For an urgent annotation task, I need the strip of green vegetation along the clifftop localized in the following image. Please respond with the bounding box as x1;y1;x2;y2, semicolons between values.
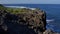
0;4;39;14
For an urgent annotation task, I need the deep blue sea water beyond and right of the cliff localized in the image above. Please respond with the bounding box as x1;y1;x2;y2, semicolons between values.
3;4;60;32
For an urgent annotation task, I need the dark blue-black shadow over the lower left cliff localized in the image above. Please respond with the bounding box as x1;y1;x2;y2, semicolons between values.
0;10;36;34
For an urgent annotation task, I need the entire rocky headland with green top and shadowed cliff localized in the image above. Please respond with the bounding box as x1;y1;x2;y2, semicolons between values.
0;5;59;34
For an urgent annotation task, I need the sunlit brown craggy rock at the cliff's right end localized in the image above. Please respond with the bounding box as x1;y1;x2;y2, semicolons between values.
18;11;46;32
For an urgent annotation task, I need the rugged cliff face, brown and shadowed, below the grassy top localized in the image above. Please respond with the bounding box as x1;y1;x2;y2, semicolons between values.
0;10;46;34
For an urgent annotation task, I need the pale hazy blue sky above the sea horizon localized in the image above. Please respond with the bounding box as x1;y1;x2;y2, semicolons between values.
0;0;60;4
